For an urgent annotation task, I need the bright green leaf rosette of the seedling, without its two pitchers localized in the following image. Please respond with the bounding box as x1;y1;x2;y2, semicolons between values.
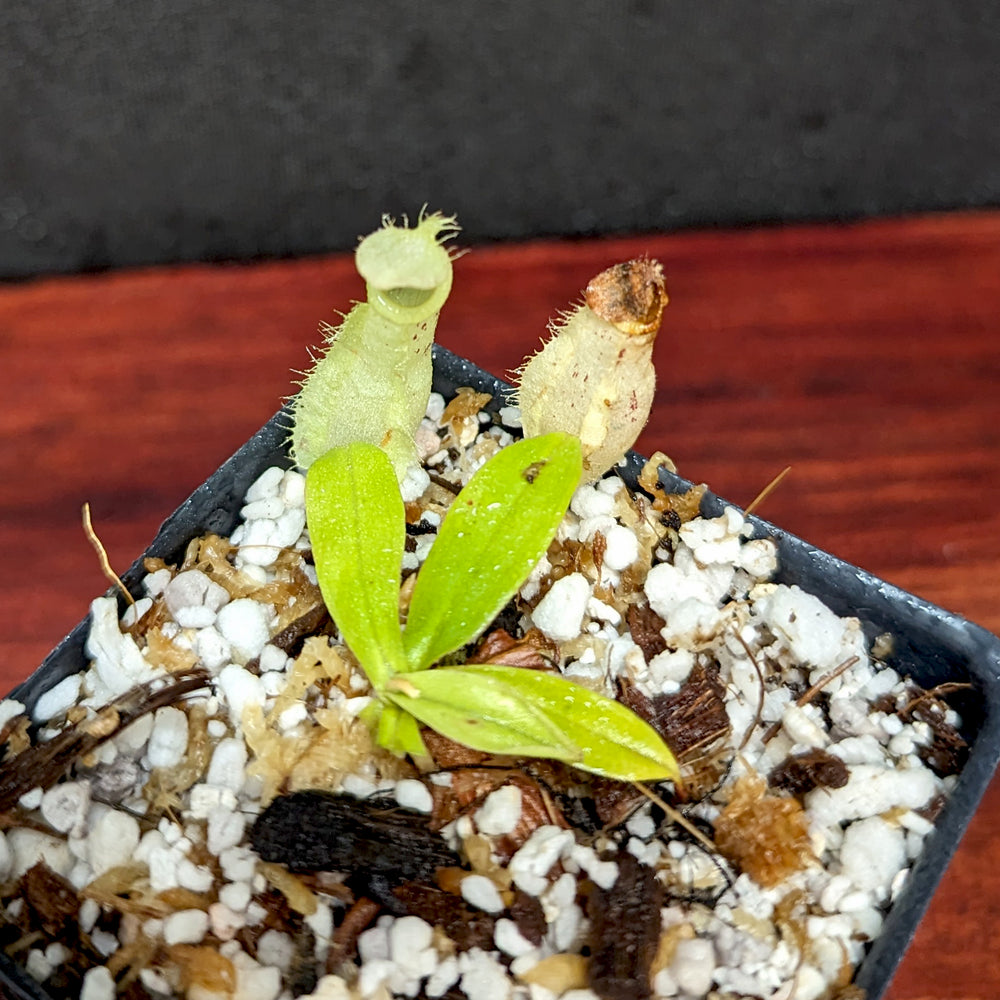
306;433;679;781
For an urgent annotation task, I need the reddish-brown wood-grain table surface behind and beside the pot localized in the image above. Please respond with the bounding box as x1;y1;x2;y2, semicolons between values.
0;213;1000;1000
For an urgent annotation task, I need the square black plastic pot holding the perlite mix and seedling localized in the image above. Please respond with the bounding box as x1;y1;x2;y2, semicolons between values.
0;347;1000;1000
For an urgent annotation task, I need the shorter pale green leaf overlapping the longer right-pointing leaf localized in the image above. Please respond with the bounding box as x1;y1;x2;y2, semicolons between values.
385;667;581;763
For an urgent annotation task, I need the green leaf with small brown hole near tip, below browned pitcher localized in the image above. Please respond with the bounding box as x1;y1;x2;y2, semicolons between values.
403;433;582;670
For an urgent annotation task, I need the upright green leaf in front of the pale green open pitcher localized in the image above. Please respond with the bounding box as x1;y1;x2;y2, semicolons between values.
306;442;406;691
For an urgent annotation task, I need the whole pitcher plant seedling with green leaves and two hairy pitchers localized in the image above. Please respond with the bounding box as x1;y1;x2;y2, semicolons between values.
291;214;679;781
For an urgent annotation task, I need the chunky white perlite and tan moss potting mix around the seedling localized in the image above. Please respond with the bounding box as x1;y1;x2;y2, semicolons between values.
0;394;959;1000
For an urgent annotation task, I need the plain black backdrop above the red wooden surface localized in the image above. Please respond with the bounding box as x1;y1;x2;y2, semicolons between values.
0;0;1000;277
